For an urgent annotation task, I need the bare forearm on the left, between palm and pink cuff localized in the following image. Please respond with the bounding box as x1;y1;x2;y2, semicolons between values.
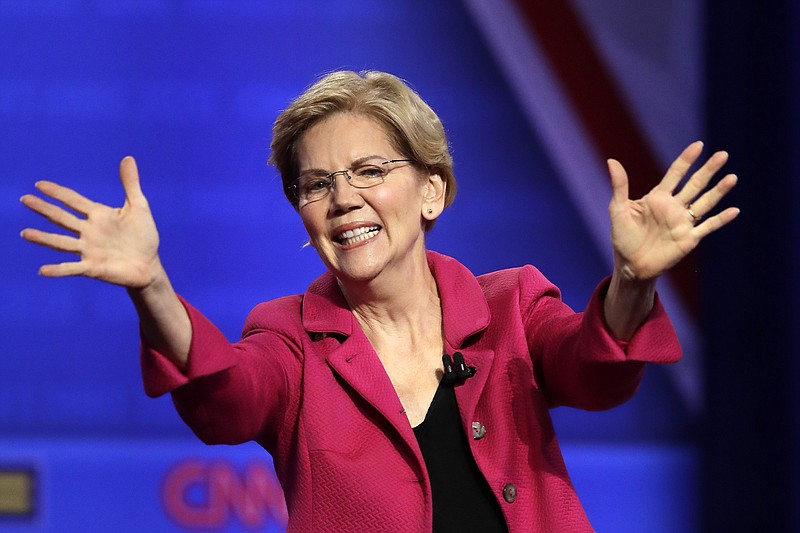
128;262;192;371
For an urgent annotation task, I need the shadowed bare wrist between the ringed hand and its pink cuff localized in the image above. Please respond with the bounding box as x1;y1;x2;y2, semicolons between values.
603;271;656;341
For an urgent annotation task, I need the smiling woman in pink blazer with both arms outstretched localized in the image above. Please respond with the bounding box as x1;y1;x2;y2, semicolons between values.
22;72;738;532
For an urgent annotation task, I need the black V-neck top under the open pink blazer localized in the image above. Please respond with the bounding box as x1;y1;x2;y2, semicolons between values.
414;382;508;533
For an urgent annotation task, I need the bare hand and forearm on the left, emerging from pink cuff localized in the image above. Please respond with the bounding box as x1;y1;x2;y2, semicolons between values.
21;157;192;370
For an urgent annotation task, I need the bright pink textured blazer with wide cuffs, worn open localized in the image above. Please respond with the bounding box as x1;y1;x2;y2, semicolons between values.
142;252;680;533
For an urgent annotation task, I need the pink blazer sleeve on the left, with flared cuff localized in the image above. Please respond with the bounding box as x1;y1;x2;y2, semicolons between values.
140;298;302;444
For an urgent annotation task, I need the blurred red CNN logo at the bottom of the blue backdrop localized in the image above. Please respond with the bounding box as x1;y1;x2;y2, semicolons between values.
161;459;287;529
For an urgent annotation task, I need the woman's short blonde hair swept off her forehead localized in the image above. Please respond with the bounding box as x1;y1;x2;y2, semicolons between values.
269;70;456;231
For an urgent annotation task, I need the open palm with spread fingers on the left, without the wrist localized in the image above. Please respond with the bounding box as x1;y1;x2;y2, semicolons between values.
20;156;165;290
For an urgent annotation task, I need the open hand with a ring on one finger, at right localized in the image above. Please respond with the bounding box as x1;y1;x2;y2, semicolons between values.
608;141;739;281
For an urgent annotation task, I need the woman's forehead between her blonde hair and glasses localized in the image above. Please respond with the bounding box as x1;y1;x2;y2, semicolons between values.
297;113;398;171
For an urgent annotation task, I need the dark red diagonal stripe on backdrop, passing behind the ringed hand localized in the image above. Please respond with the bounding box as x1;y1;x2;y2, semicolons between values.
514;0;697;313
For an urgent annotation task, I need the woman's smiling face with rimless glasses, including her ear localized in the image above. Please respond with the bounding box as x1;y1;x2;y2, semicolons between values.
297;113;444;282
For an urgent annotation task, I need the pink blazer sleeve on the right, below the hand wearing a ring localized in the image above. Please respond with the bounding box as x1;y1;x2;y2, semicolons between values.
519;267;681;410
